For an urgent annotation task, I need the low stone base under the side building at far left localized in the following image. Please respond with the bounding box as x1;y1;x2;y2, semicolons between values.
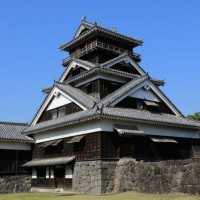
0;175;31;193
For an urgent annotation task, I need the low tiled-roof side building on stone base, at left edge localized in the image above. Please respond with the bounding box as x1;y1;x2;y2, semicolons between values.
0;122;34;193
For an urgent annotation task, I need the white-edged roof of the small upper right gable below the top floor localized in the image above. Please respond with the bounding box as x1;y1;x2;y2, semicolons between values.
101;53;146;76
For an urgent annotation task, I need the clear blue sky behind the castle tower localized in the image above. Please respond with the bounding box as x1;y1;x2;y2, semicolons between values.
0;0;200;122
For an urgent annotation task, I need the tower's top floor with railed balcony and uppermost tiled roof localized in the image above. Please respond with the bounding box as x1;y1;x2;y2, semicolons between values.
60;18;143;64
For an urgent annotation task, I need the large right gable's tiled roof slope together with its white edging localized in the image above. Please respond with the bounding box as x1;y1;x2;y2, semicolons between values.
99;76;183;116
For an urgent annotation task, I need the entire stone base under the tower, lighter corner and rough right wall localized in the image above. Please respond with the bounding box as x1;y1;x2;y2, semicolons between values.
72;159;200;194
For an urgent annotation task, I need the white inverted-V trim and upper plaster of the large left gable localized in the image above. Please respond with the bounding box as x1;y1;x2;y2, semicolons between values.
31;86;87;126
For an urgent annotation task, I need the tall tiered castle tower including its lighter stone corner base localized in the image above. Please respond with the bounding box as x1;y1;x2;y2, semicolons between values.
20;19;200;194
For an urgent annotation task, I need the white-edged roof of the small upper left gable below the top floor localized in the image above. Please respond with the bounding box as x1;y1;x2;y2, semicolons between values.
59;59;95;82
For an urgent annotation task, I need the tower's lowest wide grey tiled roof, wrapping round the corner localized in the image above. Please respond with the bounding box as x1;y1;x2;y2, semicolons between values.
24;106;200;134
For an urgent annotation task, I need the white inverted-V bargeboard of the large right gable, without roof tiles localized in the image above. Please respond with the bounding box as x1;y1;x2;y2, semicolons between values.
110;80;182;116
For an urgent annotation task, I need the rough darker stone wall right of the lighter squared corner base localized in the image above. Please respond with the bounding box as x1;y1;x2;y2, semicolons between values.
111;159;200;194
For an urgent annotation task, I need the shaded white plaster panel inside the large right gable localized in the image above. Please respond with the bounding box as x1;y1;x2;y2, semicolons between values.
129;88;160;102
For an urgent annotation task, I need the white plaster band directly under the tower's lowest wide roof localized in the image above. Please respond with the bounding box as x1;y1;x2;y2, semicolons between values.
34;120;199;143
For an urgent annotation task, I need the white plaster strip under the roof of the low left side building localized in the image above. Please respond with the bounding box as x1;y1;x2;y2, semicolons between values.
0;141;31;150
